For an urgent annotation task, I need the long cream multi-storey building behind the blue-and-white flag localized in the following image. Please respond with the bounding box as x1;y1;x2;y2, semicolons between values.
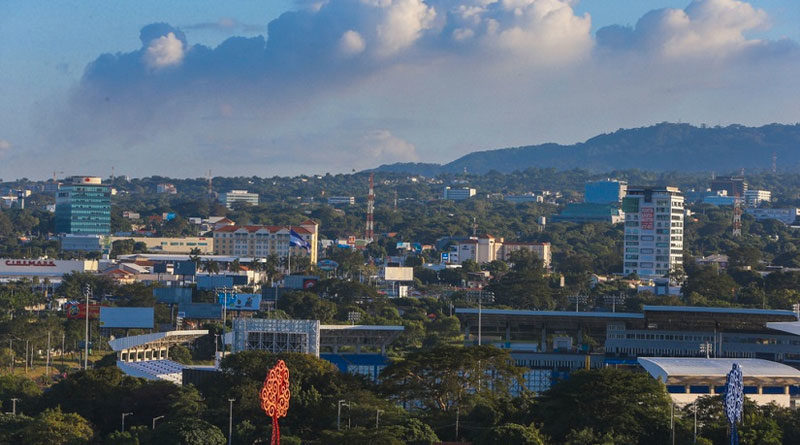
214;220;319;264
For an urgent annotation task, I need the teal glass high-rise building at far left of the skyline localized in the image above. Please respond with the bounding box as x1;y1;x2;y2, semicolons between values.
55;176;111;235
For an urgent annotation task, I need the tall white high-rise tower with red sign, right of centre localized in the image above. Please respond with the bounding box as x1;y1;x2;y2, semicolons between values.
622;187;684;278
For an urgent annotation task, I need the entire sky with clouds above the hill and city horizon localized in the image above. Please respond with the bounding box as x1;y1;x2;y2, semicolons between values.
0;0;800;178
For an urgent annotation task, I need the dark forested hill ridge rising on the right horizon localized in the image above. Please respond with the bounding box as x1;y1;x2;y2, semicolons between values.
375;123;800;177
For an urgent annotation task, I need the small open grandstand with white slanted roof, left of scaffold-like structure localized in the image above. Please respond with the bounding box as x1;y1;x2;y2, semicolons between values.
108;330;208;385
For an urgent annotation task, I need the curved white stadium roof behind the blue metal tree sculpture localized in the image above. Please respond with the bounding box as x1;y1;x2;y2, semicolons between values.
638;357;800;385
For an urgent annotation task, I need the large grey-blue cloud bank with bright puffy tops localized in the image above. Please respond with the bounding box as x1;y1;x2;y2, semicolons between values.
43;0;800;174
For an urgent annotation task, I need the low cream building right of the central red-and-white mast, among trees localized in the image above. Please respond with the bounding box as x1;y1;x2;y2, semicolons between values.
449;235;552;267
